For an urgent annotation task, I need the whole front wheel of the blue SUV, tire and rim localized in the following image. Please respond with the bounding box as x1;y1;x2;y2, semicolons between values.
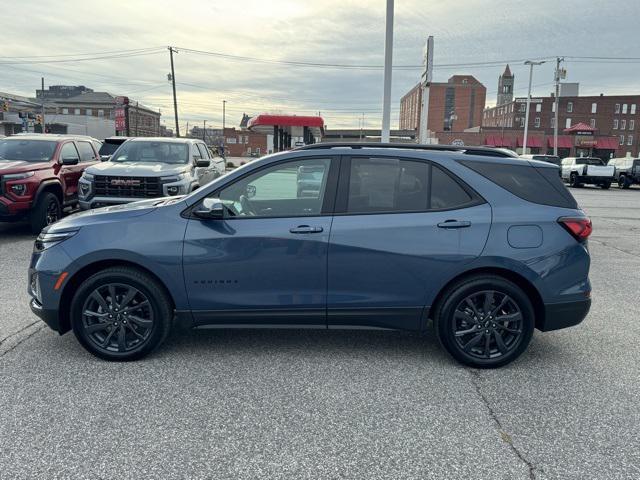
71;267;173;361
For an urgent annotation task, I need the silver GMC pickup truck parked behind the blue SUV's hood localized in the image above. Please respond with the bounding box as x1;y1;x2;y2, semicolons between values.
80;137;225;210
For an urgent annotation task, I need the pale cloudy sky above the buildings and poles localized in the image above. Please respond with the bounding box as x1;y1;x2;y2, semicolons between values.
0;0;640;128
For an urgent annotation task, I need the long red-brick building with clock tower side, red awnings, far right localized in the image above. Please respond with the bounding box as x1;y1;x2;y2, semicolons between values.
482;95;640;156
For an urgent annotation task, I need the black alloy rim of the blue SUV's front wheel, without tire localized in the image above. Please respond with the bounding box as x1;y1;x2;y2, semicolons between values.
82;283;154;353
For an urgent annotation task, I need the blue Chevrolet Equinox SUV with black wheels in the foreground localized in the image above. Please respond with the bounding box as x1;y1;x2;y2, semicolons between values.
29;144;591;368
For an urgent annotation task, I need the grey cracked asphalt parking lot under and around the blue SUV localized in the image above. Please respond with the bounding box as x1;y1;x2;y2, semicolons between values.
0;187;640;479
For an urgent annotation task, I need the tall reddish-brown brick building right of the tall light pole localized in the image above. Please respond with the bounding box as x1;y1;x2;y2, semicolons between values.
400;75;487;132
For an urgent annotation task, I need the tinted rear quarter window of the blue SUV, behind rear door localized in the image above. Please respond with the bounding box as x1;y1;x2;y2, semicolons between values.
460;160;578;208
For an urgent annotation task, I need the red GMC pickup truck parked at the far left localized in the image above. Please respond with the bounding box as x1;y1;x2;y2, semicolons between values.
0;134;99;234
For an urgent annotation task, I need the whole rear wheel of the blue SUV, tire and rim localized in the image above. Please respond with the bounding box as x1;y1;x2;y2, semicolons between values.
433;275;535;368
